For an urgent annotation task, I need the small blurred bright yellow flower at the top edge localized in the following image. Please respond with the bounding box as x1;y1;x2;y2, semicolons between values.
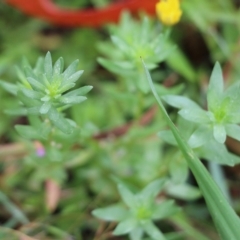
156;0;182;26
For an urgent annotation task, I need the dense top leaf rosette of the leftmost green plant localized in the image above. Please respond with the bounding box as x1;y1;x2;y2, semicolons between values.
1;53;92;133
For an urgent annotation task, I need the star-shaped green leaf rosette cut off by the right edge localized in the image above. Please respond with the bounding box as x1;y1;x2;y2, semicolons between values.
163;63;240;144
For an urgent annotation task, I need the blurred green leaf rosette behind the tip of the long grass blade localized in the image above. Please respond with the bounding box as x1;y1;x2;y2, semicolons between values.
98;12;174;93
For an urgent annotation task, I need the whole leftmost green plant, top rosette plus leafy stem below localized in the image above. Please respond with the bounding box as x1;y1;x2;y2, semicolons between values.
1;52;92;182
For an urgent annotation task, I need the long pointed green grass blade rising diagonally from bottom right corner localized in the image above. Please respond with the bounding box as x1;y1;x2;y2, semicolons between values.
143;58;240;240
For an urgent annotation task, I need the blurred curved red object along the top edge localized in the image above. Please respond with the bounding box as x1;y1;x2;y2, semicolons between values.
5;0;159;27
